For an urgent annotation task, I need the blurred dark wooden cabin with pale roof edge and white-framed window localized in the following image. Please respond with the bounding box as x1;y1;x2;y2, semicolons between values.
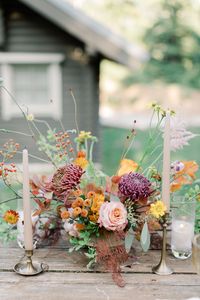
0;0;146;164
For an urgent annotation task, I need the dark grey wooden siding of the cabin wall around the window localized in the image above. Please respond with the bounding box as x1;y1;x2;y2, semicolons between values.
0;0;99;163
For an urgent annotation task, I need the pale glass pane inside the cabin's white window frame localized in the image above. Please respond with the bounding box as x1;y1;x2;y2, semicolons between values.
12;64;49;106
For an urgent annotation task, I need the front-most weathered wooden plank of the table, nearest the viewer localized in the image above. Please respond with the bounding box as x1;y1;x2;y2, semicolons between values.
0;273;200;300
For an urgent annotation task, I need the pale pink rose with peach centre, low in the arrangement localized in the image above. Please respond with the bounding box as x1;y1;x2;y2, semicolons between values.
98;201;128;231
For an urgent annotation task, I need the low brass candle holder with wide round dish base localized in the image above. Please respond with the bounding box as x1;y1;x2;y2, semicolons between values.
14;250;48;276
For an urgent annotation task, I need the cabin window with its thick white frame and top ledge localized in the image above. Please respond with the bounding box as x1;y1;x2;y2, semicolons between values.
0;53;63;120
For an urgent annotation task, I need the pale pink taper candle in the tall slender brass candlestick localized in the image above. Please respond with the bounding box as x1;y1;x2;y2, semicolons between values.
162;111;170;212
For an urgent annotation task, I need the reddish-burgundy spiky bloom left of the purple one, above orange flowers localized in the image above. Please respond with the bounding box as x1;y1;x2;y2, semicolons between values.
49;164;84;201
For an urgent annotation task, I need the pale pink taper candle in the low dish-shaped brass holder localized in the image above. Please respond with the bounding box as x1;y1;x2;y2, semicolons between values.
23;149;33;250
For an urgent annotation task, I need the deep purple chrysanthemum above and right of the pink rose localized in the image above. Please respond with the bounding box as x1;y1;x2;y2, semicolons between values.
118;172;152;200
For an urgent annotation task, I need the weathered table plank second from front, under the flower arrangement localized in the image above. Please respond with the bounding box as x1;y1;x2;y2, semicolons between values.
0;248;195;274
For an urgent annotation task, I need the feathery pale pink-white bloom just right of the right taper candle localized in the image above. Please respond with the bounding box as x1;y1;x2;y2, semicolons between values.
170;117;197;151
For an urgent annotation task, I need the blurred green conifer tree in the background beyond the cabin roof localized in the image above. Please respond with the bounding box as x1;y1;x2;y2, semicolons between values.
143;0;200;88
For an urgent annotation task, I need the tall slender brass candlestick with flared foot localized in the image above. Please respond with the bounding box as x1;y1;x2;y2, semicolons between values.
152;214;173;275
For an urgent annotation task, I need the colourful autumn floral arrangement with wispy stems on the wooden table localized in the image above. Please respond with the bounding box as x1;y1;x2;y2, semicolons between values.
0;83;200;286
